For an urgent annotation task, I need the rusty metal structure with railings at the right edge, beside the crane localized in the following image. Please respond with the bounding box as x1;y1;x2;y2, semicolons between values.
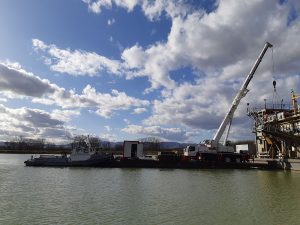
247;89;300;159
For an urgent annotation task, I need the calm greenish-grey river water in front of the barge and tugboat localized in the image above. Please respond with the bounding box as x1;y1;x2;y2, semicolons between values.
0;154;300;225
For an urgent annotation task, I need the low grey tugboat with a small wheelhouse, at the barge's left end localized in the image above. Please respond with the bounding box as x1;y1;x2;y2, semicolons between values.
24;136;113;167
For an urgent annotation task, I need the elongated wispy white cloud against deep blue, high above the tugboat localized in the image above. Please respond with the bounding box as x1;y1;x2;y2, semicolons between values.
32;39;122;76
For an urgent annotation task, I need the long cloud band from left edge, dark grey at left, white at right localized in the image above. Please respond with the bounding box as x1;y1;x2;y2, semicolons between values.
0;61;150;118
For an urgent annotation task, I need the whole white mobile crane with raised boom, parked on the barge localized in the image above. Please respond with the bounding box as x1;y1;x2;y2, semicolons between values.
184;42;273;162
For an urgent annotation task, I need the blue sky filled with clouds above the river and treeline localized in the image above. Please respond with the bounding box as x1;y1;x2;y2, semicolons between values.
0;0;300;143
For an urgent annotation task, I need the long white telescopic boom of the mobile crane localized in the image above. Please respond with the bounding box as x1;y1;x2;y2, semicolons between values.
212;42;273;144
